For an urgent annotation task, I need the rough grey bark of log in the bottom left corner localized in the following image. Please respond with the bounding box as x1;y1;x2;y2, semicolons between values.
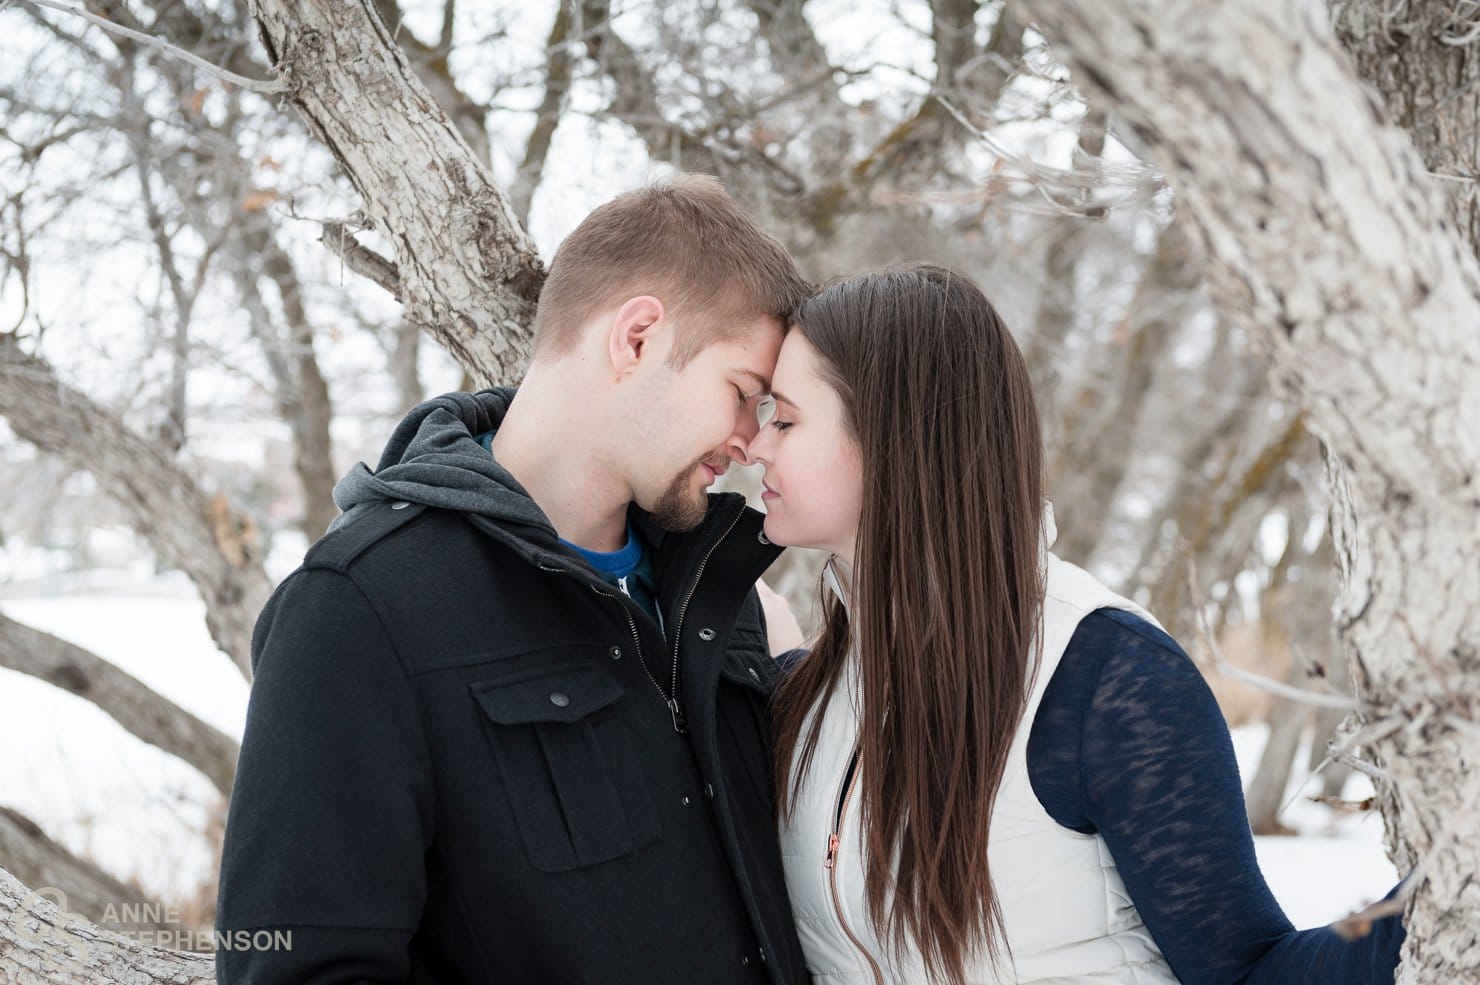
0;868;216;985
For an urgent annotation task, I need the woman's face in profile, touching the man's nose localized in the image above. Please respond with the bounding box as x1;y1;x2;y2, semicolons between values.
747;328;863;565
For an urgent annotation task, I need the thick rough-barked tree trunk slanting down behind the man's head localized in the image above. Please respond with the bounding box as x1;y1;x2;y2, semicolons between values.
252;0;545;383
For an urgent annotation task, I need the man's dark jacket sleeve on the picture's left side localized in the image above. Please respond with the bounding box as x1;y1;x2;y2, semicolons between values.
216;569;432;985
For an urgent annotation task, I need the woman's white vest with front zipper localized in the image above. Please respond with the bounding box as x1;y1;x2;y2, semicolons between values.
780;519;1177;985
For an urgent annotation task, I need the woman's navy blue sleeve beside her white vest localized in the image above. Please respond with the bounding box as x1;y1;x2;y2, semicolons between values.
1029;609;1403;985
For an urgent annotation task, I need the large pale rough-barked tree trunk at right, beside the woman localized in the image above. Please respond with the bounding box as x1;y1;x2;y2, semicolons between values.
1032;0;1480;985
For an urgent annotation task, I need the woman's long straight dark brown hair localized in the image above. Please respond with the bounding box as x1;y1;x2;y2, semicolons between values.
774;265;1043;985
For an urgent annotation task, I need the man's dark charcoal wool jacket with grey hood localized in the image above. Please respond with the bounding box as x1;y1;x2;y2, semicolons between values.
218;389;808;985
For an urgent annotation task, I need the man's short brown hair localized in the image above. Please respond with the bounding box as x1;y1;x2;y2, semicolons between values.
534;175;808;368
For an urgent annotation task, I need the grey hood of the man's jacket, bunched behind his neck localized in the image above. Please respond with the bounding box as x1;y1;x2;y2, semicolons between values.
330;386;556;540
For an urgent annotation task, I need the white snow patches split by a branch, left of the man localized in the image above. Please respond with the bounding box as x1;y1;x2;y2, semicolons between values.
0;564;247;901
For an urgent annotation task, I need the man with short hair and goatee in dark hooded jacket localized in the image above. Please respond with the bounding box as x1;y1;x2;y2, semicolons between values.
218;176;808;985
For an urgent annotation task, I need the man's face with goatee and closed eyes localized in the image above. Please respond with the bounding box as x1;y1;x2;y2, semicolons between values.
633;317;783;531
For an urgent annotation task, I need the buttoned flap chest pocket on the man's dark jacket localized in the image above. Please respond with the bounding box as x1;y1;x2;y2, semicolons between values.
469;667;660;873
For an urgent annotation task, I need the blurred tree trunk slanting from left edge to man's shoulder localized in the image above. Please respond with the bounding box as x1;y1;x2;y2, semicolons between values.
0;334;272;676
